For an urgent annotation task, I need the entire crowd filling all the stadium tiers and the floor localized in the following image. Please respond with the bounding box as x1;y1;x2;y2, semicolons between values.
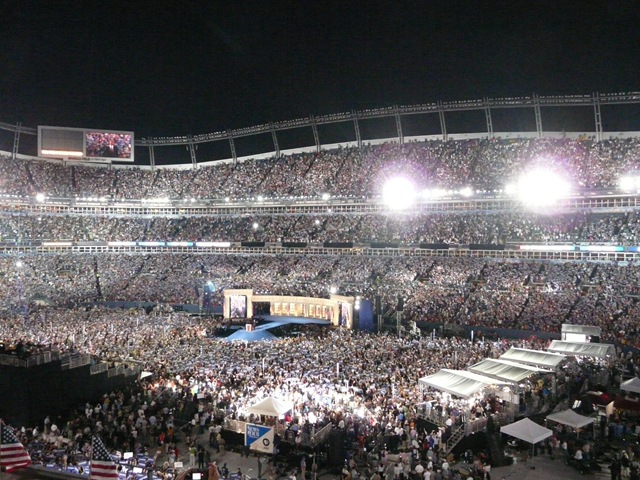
0;138;640;480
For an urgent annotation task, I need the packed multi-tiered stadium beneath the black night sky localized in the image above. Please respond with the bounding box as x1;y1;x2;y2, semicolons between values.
0;93;640;478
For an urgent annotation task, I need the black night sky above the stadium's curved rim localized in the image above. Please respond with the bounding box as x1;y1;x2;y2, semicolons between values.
0;0;640;137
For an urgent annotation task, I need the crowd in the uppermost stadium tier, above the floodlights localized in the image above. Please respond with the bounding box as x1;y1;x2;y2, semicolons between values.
0;137;640;199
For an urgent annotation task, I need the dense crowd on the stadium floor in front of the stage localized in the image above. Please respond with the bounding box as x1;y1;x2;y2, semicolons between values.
0;307;635;479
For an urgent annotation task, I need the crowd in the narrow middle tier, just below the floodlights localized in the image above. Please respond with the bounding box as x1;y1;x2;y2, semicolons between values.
0;211;640;245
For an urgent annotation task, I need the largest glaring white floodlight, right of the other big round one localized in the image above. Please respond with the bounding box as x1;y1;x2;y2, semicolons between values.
517;168;571;208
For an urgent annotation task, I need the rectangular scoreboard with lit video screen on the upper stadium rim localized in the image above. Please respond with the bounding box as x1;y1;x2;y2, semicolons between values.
38;126;134;163
